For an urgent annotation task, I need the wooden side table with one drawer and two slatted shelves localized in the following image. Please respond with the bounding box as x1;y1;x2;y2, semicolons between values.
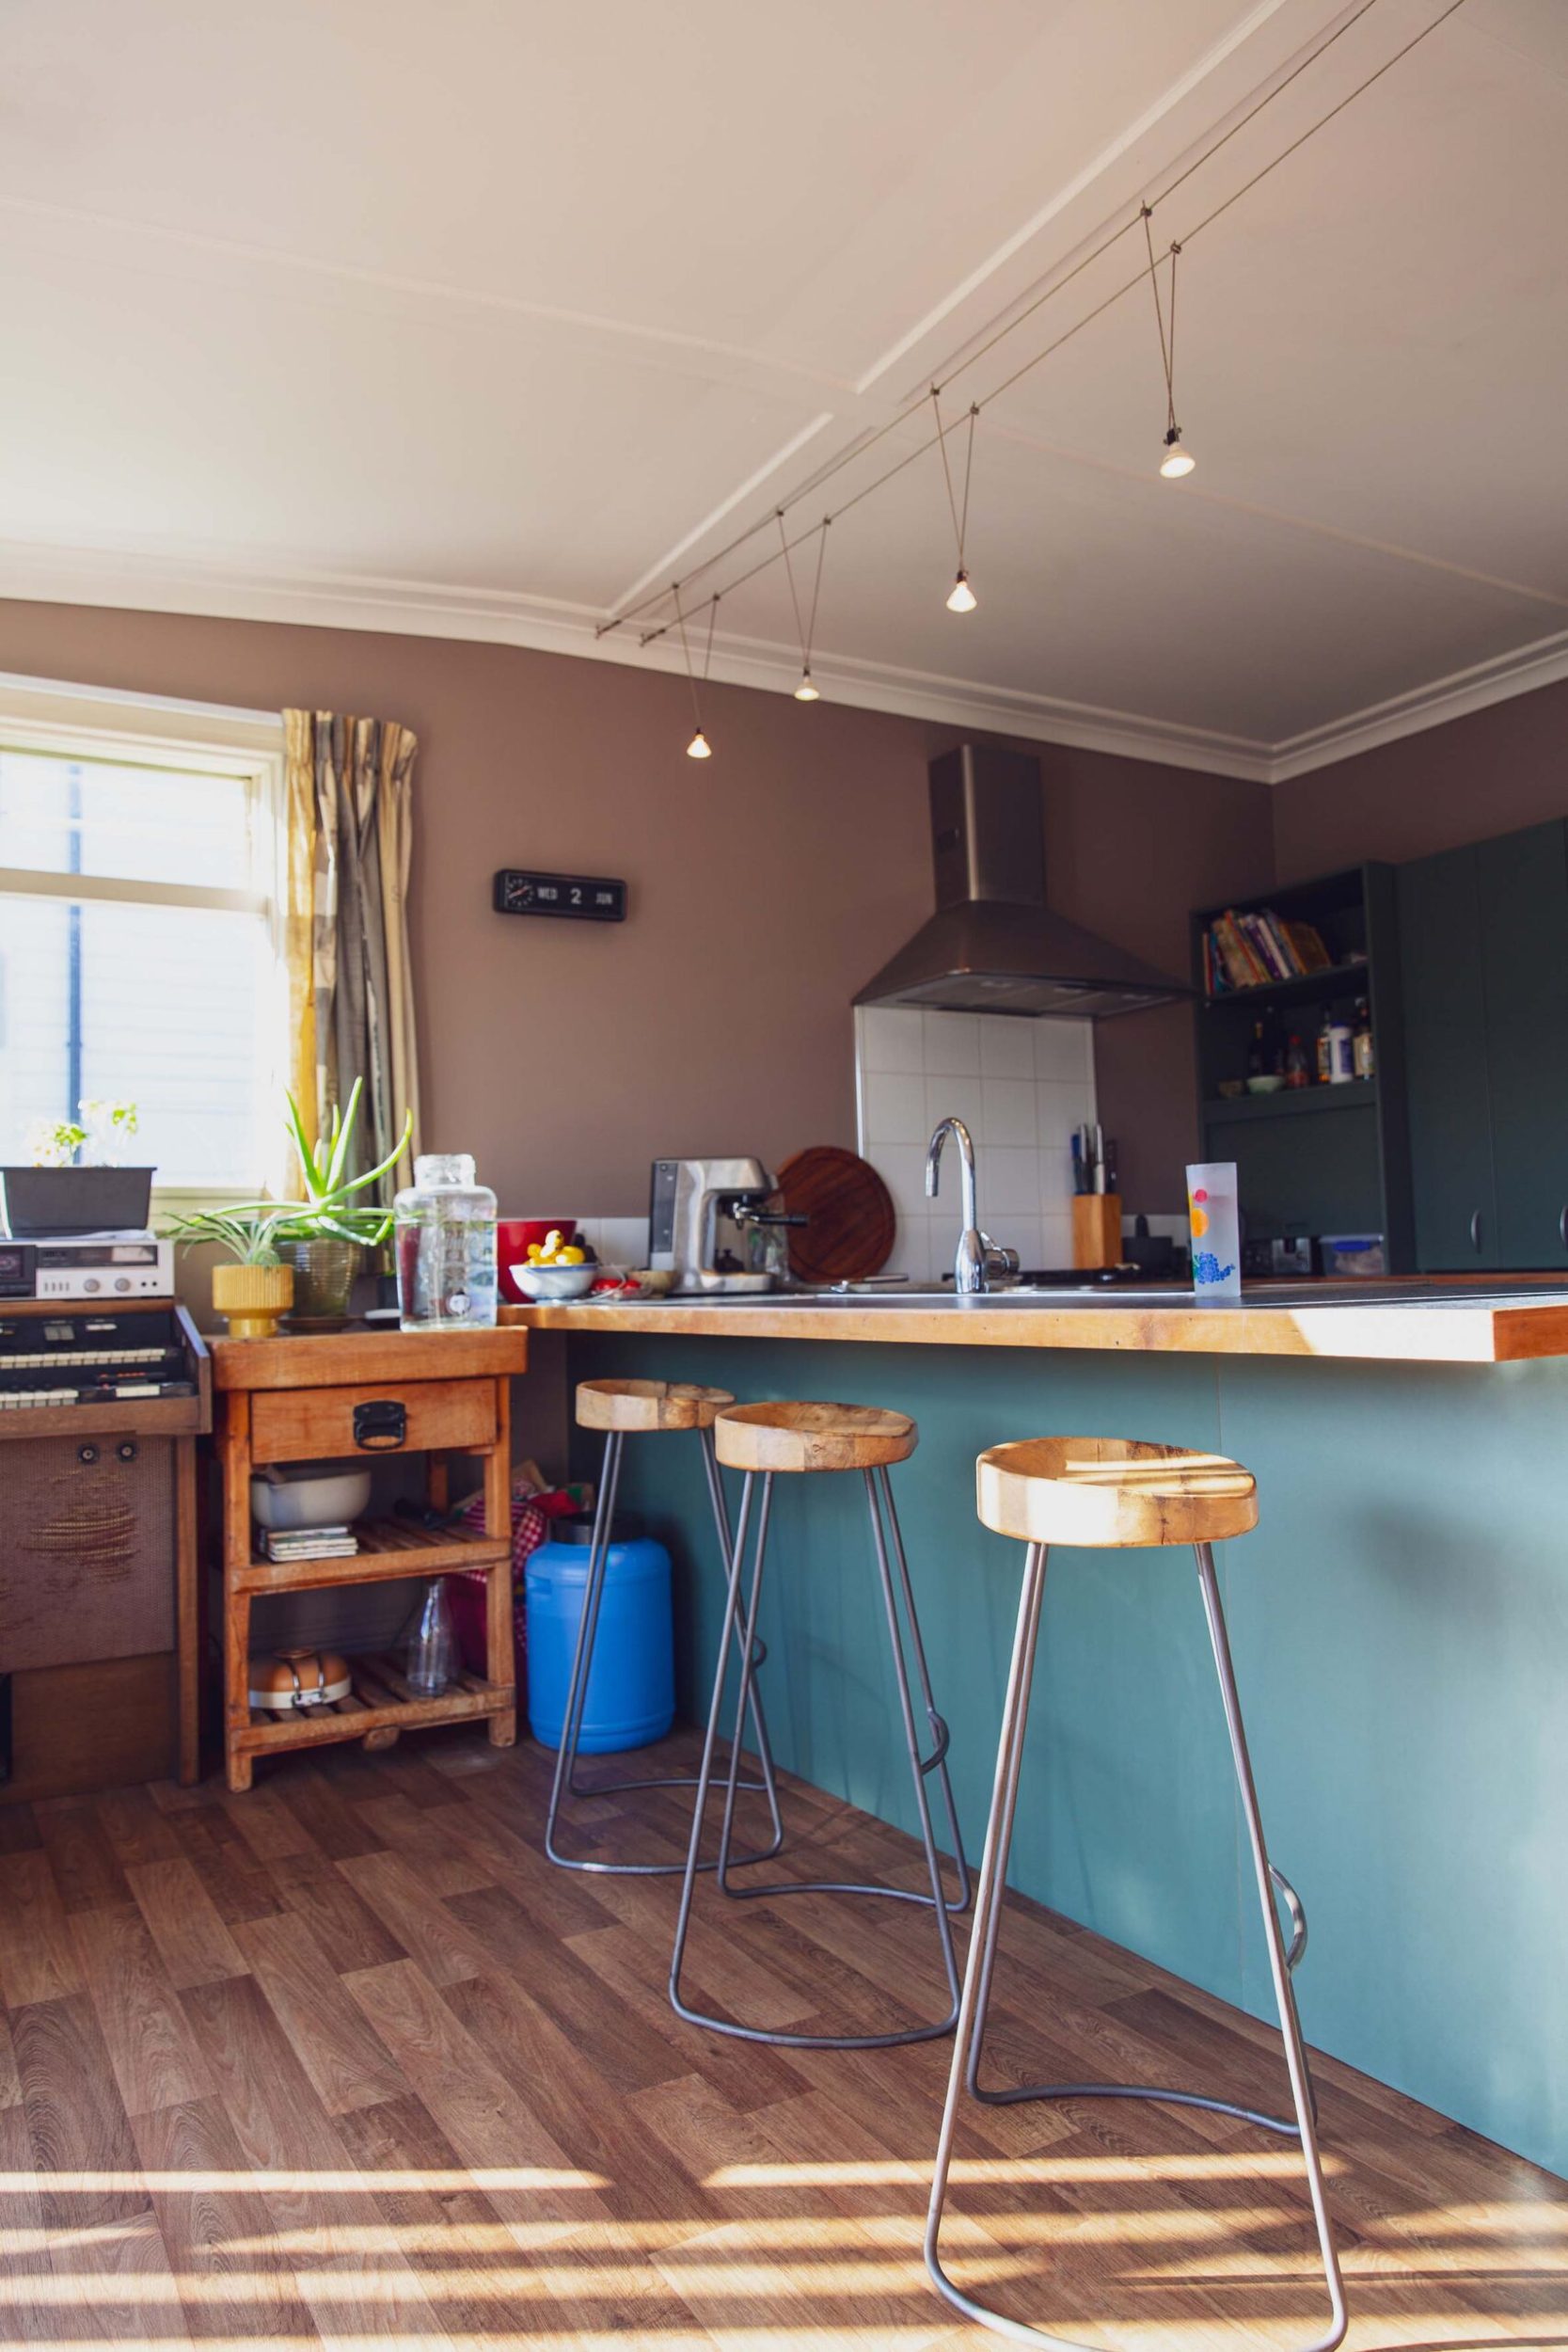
212;1329;529;1790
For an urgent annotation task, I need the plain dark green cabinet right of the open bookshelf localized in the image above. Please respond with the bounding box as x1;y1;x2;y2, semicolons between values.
1399;818;1568;1273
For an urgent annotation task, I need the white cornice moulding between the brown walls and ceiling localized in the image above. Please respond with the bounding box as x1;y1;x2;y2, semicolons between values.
0;544;1568;784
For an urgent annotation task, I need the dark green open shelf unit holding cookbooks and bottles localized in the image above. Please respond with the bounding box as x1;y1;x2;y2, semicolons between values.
1192;864;1416;1273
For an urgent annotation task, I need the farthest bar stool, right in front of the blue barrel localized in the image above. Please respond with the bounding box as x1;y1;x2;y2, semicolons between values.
546;1381;783;1880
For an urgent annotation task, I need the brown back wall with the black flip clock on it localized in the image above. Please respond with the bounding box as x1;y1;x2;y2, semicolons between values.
0;602;1272;1216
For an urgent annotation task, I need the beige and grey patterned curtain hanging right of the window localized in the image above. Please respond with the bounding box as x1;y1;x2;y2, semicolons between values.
282;710;420;1200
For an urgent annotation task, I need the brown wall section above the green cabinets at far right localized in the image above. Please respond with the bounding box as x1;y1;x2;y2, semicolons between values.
1275;685;1568;882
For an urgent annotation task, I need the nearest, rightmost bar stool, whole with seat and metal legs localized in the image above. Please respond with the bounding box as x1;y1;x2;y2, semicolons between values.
927;1438;1347;2352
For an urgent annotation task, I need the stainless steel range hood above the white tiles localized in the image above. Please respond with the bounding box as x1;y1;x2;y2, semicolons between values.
856;743;1192;1021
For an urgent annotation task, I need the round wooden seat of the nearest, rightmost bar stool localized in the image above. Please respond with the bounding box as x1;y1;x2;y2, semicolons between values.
973;1423;1258;1550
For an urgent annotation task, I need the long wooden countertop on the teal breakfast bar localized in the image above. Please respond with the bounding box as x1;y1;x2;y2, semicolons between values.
500;1278;1568;1364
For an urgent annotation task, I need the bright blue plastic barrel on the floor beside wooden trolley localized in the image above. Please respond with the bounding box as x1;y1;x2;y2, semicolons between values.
527;1524;674;1755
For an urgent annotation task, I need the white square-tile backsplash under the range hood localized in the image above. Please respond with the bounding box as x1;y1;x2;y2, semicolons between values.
856;1005;1096;1282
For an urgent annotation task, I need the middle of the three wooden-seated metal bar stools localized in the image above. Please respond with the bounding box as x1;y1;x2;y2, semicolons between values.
670;1405;969;2051
